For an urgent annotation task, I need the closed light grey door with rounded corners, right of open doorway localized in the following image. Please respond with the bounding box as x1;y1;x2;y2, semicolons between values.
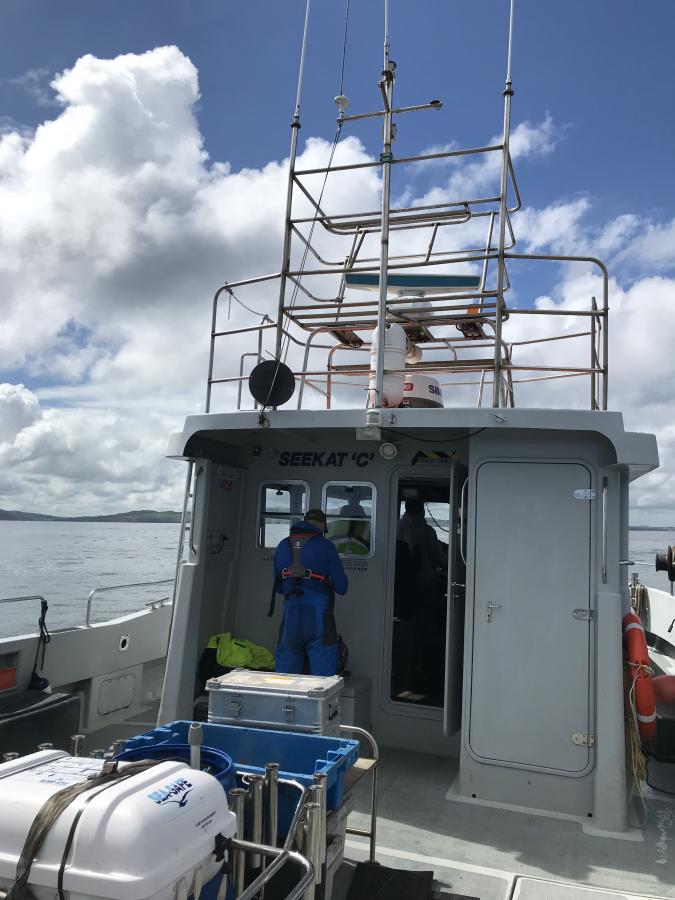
469;462;592;773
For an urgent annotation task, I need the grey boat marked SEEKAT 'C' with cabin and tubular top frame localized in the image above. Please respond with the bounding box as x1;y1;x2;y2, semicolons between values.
0;0;675;900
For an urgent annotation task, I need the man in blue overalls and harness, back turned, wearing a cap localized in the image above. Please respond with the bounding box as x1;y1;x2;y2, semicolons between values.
269;509;348;675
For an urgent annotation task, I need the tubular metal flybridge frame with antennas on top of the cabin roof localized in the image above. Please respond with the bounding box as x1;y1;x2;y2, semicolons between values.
206;2;608;419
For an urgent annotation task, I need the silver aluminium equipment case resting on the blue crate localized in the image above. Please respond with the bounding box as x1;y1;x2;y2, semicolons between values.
206;669;344;737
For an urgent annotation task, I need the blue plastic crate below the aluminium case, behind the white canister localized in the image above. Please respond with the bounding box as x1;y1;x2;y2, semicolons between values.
119;721;359;833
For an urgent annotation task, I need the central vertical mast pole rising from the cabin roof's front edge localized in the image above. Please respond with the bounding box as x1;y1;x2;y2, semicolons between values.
375;0;395;409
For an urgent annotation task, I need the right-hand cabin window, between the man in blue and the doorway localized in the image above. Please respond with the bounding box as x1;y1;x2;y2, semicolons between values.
323;481;375;557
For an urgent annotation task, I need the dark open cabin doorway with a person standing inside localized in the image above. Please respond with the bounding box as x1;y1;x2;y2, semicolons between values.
390;472;464;716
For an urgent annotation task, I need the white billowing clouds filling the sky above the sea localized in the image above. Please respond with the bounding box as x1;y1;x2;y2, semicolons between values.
0;47;675;516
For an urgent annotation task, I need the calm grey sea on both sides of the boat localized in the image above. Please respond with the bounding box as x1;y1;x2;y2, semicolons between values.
0;522;675;636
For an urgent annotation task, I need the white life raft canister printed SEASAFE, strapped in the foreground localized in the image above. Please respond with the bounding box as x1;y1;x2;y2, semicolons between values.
0;750;236;900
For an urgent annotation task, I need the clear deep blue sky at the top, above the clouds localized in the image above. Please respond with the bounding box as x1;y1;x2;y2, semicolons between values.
5;0;675;215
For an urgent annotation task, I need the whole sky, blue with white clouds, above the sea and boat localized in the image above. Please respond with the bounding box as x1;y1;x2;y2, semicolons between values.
0;0;675;525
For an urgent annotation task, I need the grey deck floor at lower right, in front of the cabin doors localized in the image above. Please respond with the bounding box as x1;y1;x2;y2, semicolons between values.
345;749;675;900
